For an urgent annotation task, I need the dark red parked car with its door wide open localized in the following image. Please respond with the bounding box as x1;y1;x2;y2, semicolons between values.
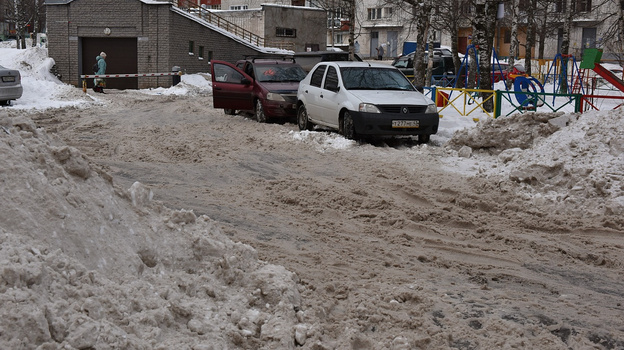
211;58;306;123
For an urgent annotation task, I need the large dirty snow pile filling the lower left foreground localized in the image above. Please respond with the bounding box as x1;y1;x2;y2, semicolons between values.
0;111;308;350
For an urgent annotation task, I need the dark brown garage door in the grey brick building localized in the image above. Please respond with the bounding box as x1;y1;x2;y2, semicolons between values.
81;38;139;89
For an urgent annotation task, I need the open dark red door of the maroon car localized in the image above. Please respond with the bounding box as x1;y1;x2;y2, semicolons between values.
210;60;254;110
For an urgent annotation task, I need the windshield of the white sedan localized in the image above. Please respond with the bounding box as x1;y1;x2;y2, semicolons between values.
340;67;414;91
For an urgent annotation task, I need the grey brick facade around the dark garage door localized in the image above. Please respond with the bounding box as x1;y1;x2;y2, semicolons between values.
46;0;262;89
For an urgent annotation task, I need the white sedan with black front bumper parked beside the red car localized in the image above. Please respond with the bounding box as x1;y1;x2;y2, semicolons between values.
297;62;440;143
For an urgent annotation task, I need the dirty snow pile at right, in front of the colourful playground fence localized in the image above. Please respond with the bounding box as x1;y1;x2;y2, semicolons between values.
448;109;624;229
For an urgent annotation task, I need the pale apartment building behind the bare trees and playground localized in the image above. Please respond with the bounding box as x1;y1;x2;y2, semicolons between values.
309;0;622;59
